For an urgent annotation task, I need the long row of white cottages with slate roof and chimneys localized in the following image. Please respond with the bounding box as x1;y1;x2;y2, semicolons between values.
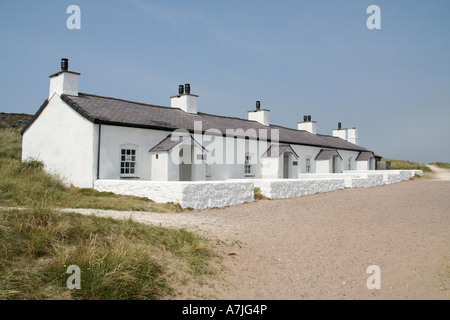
22;59;377;188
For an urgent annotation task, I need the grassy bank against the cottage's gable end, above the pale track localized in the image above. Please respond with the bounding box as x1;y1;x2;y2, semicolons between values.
0;129;183;212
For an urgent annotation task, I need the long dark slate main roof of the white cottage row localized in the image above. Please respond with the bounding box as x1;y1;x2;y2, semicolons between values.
22;93;369;152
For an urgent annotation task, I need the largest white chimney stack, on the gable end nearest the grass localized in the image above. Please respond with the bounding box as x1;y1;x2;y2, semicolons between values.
49;58;80;98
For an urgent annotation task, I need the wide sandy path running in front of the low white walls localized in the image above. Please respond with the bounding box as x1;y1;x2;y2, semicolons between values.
67;180;450;299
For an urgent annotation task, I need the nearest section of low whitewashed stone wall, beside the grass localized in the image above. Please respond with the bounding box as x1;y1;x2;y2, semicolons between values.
94;180;254;209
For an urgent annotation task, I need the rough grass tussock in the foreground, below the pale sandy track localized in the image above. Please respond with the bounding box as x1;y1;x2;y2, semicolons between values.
0;209;212;300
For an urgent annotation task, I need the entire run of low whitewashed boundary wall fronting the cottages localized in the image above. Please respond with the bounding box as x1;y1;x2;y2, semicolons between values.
94;170;423;209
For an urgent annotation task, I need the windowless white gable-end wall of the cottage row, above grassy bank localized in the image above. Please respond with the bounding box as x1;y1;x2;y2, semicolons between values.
22;94;96;188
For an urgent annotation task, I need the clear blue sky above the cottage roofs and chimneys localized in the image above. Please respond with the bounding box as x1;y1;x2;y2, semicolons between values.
0;0;450;163
